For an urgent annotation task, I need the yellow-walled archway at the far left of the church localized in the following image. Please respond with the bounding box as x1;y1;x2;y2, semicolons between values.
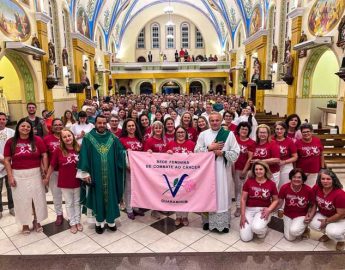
0;51;35;121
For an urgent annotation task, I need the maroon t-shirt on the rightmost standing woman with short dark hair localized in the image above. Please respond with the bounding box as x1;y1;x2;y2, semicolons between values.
296;136;323;173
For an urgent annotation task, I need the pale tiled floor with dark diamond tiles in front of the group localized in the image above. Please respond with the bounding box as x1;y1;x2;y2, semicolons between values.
0;174;344;255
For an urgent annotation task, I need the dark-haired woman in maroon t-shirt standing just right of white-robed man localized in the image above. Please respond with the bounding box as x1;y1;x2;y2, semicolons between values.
233;122;255;217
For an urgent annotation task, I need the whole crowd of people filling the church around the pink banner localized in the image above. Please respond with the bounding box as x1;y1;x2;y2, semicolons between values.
0;94;345;250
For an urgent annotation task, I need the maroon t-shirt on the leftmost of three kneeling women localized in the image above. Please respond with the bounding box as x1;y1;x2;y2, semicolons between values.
243;178;278;207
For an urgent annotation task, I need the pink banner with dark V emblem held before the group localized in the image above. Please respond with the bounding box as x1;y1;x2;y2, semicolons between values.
128;151;217;212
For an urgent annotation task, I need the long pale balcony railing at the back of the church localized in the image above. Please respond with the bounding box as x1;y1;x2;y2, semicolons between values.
111;61;230;73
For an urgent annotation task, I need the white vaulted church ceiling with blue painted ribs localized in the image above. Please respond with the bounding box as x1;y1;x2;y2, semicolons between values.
67;0;272;49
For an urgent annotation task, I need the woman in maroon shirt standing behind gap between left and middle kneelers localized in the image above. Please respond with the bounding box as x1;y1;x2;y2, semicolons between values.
273;121;297;189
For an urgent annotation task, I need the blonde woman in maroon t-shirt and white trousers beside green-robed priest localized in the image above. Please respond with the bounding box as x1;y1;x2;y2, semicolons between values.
43;129;83;234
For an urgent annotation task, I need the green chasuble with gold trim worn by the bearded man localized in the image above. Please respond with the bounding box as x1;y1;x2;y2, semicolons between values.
78;129;126;223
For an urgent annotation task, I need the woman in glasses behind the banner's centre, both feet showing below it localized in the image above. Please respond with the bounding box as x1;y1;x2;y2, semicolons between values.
167;126;195;226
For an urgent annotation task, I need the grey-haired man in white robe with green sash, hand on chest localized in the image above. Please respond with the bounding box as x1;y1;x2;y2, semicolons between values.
194;112;240;233
